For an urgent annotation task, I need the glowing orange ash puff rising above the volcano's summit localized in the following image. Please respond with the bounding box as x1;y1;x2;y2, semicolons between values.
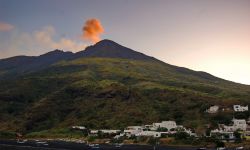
82;19;104;43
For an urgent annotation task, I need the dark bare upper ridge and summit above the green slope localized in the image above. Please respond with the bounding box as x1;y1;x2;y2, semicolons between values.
0;39;242;85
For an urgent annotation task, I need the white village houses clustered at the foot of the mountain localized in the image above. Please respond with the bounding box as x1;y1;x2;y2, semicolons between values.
72;105;250;147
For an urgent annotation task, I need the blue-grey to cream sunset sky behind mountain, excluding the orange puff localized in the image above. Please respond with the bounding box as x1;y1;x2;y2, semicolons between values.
0;0;250;85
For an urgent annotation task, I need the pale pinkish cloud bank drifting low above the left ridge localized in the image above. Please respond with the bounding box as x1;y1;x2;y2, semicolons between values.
0;26;87;58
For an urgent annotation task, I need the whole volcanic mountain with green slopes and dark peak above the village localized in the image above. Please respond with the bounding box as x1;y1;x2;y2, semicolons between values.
0;40;250;134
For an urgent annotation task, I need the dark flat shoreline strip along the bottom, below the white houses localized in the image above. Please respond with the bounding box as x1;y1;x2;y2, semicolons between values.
0;140;236;150
